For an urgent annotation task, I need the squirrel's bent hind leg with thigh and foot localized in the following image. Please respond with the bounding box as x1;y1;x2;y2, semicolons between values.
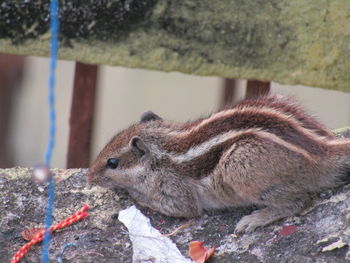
213;133;317;232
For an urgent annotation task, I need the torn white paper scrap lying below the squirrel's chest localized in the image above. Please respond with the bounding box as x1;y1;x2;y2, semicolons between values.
118;206;193;263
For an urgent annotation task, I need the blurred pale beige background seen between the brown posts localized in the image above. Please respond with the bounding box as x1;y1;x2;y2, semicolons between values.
0;54;350;168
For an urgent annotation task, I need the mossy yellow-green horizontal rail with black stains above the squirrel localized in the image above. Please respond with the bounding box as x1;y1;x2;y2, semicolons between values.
0;0;350;91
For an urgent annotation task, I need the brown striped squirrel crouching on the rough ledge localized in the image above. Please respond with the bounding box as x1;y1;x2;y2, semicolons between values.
87;95;350;233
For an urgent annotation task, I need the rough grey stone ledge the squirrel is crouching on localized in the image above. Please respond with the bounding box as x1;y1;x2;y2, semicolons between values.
0;168;350;263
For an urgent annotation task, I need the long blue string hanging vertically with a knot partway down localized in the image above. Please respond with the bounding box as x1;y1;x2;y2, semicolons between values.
41;0;59;263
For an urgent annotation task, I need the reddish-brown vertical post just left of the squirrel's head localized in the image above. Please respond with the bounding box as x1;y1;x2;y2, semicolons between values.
67;62;98;168
